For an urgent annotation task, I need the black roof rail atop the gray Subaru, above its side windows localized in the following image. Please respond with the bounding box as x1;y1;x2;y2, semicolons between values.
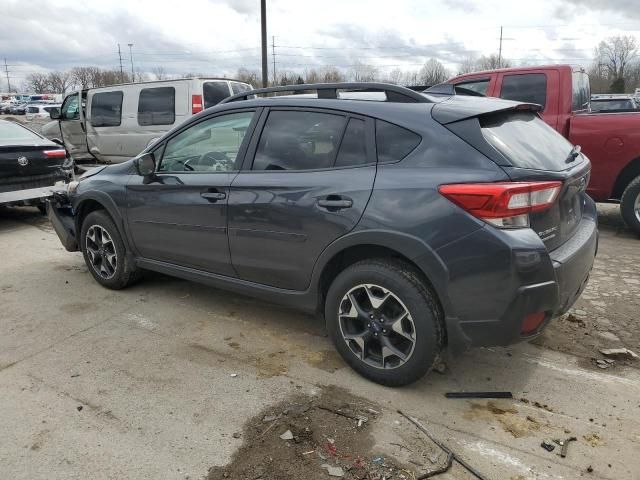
220;82;433;103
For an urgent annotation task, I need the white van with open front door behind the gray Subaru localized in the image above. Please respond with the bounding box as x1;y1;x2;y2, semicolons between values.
42;78;251;163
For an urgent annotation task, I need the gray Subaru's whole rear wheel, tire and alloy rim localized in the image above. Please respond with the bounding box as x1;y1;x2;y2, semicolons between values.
325;259;444;386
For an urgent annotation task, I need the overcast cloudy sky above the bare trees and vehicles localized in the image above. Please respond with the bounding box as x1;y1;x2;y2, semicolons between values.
0;0;640;90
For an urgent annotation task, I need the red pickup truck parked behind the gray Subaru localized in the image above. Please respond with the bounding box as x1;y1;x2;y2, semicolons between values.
447;65;640;235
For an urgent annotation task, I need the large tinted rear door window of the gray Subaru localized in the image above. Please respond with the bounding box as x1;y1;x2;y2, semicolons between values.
253;111;345;170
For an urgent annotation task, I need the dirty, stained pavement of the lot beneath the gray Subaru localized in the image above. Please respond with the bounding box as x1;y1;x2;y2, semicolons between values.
0;206;640;480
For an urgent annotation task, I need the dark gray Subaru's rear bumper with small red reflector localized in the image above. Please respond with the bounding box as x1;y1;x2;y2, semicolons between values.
438;199;598;351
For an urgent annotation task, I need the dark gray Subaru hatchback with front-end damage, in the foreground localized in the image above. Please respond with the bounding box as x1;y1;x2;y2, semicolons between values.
49;84;598;385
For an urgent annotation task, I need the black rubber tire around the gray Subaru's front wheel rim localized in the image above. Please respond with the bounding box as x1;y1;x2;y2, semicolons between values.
80;210;140;290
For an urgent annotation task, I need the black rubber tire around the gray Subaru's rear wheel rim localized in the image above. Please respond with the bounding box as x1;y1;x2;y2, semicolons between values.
325;259;445;386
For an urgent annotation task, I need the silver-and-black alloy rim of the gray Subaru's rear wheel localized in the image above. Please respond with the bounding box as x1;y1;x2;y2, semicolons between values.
338;284;416;369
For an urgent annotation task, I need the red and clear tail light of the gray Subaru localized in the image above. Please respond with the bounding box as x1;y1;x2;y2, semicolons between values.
438;181;562;228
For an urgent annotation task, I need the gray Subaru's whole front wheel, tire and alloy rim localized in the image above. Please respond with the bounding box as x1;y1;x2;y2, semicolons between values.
80;210;139;290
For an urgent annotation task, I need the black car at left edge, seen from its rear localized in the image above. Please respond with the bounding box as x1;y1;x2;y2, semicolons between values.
0;120;73;211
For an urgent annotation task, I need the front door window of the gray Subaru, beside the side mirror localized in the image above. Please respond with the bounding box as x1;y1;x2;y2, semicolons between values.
158;111;254;172
